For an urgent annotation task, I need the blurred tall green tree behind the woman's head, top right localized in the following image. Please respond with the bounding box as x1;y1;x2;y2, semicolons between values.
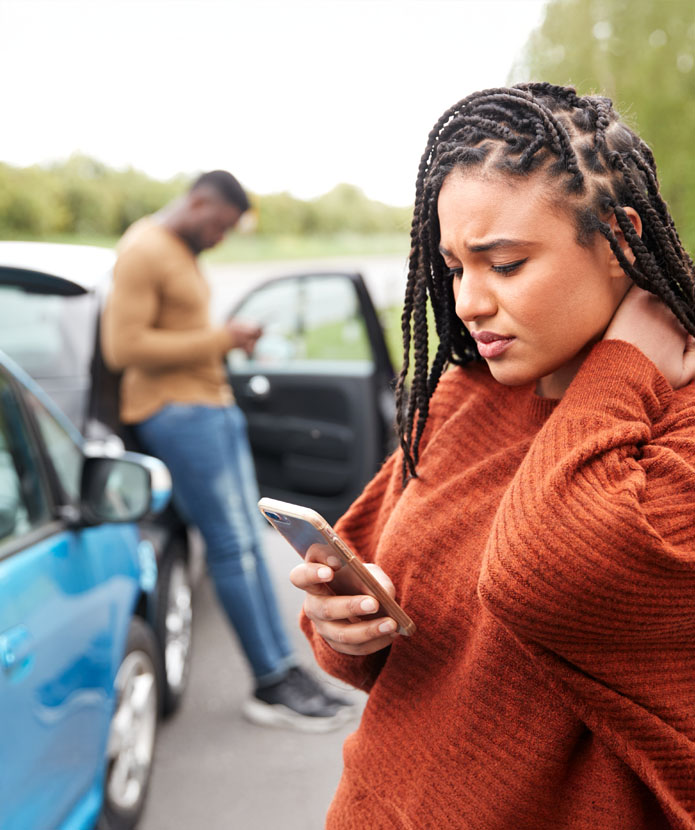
510;0;695;252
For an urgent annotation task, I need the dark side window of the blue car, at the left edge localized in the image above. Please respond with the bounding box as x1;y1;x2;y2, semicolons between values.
0;376;49;543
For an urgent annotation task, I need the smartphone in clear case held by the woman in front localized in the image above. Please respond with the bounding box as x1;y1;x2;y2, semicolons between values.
258;498;415;637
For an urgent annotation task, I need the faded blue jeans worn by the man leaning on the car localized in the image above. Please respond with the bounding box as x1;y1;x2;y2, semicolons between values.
135;404;297;686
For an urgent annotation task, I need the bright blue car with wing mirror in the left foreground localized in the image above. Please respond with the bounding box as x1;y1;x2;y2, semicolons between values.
0;353;171;830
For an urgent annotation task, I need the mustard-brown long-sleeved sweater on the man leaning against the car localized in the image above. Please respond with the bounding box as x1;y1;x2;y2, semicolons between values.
101;217;232;424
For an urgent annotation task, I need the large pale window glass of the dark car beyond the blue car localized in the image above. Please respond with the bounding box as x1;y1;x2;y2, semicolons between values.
0;285;96;378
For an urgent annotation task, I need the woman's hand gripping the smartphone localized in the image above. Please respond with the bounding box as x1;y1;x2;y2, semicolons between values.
290;562;400;655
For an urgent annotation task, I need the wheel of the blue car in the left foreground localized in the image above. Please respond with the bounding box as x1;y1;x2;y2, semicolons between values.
97;617;160;830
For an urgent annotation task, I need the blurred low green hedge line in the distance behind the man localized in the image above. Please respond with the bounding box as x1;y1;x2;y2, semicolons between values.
0;155;411;239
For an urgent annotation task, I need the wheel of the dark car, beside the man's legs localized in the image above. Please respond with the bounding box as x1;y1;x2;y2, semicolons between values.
155;541;193;717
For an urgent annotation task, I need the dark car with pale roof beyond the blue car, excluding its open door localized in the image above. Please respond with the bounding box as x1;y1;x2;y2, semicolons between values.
0;241;198;716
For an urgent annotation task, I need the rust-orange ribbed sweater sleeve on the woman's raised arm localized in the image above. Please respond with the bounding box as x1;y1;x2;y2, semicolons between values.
478;341;695;828
